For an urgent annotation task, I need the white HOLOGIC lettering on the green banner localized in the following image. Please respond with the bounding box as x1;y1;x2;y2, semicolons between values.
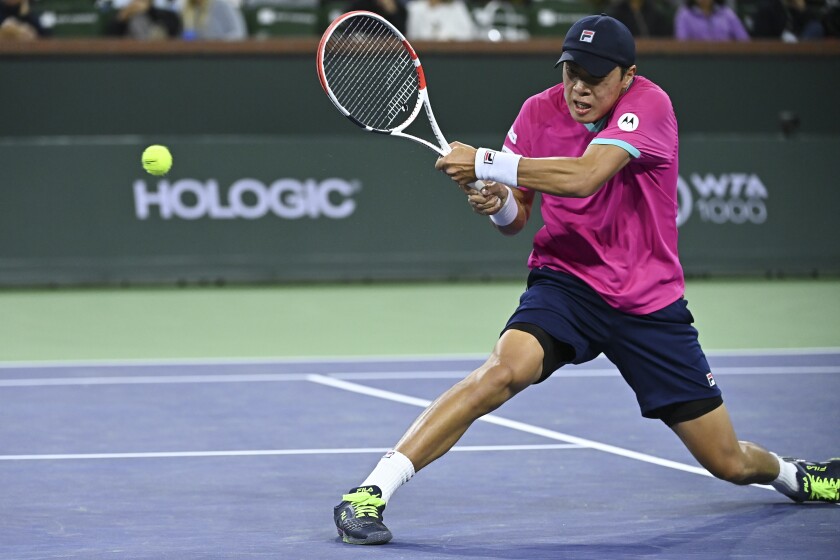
134;178;361;220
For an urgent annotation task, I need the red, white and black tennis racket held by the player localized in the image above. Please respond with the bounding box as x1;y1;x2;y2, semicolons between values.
317;11;483;188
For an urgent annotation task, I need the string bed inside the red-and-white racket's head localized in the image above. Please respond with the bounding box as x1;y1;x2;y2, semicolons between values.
323;16;419;130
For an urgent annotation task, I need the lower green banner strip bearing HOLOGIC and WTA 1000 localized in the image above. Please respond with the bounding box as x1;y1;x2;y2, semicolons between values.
0;135;840;286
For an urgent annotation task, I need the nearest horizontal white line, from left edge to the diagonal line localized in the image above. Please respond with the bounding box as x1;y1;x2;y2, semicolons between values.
0;443;582;461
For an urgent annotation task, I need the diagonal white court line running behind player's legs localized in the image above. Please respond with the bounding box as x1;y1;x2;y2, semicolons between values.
309;374;775;491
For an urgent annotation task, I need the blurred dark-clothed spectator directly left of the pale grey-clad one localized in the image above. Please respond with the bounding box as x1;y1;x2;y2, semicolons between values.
105;0;181;40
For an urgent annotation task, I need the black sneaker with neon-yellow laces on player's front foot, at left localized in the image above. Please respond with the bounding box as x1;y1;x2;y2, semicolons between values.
333;486;391;544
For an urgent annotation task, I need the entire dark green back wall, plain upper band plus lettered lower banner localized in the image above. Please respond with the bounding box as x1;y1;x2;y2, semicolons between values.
0;47;840;286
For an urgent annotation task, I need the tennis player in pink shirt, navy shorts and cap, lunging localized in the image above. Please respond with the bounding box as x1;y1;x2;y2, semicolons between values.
334;15;840;544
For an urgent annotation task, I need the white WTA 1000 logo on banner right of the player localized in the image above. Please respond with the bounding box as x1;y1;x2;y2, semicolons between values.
677;173;767;226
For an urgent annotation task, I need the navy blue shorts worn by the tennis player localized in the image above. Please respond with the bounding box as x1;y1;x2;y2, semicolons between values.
505;268;722;419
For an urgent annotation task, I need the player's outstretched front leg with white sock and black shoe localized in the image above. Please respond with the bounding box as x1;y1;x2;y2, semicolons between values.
333;330;543;544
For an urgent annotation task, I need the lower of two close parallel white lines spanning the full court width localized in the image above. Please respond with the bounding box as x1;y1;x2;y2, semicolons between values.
0;366;840;387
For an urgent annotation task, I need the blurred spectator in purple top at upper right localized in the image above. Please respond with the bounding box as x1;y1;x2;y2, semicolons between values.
674;0;750;41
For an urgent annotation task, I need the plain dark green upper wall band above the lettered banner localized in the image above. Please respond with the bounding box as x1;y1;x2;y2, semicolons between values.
6;54;840;136
